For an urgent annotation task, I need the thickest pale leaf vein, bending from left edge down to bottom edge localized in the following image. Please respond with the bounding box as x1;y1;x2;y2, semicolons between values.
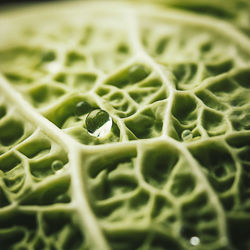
0;76;109;250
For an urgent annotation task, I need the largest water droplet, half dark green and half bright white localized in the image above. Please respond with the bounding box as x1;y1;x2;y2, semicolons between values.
85;109;112;137
